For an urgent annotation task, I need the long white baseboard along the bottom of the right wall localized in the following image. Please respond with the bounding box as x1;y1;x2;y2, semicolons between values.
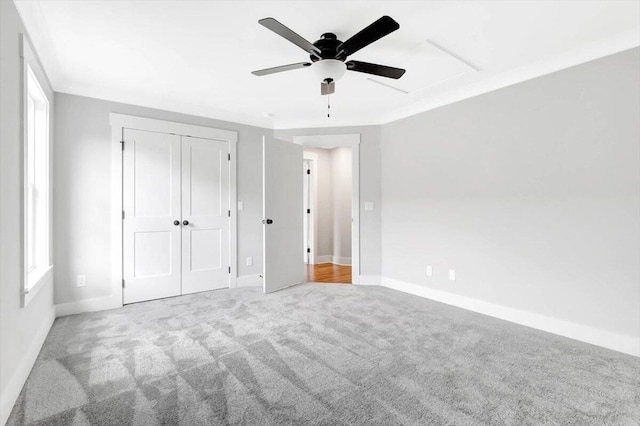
381;277;640;356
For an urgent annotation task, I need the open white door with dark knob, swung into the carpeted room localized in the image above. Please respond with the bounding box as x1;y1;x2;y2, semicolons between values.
262;136;305;293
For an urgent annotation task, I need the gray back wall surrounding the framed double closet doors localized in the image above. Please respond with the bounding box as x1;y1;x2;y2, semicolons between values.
54;93;272;303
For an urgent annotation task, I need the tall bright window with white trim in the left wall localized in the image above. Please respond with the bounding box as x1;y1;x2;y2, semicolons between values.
23;36;51;304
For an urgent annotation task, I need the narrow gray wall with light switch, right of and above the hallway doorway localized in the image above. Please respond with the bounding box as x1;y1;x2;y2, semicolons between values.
274;126;381;275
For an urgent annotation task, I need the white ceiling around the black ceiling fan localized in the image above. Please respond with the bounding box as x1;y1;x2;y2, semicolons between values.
16;0;640;128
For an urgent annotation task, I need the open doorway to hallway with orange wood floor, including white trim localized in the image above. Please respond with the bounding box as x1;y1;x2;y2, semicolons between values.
293;134;360;284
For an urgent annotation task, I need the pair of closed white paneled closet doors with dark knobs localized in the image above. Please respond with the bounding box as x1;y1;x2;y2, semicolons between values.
122;128;231;304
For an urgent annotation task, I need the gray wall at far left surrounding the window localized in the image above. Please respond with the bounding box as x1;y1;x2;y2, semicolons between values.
0;1;55;424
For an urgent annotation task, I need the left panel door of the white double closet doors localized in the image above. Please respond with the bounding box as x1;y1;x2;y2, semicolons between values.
123;129;182;304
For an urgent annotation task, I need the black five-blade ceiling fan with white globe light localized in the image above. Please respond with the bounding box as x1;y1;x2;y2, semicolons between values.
251;16;405;95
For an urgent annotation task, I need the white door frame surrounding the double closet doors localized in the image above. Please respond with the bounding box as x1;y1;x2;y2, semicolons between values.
108;113;238;307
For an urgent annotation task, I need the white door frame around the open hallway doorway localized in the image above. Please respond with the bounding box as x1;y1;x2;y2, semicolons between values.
293;133;360;284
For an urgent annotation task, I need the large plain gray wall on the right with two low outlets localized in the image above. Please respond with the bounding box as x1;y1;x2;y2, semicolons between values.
382;49;640;336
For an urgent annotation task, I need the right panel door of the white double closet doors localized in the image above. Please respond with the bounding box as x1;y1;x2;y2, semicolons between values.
182;137;230;294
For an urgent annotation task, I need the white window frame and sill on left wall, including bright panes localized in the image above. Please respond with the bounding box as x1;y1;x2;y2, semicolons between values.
20;34;53;307
